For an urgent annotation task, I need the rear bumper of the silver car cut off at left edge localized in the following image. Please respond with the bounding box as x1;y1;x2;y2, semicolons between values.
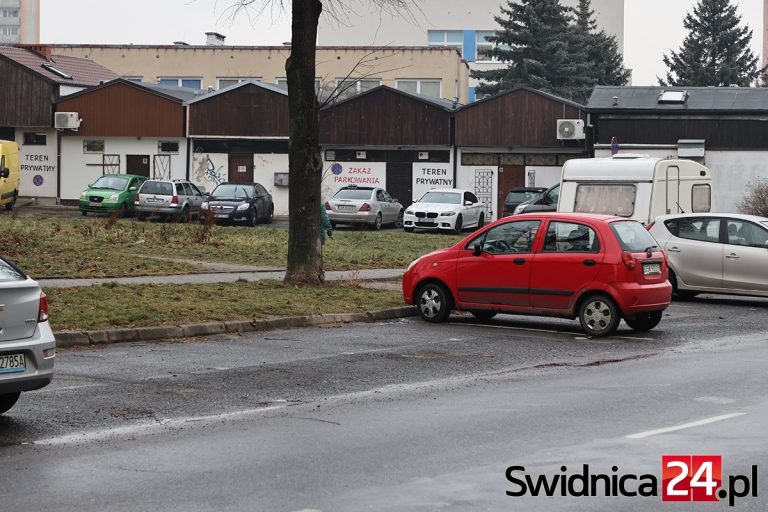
0;322;56;394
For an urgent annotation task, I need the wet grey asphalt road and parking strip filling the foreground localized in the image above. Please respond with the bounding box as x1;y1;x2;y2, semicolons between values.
0;298;768;512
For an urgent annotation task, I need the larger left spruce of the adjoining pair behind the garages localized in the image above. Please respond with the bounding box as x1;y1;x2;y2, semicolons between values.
472;0;578;98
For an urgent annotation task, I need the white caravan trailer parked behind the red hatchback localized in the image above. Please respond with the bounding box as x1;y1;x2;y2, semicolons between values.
557;153;713;224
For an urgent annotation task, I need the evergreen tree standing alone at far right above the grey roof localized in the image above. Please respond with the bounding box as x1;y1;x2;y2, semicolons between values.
658;0;765;87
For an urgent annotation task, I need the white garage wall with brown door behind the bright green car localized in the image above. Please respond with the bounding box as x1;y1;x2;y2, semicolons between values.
61;137;187;200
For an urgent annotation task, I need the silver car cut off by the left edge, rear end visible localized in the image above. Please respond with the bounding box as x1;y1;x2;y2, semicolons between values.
0;258;56;414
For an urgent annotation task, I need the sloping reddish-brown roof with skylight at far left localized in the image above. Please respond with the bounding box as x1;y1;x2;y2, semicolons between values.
0;46;119;86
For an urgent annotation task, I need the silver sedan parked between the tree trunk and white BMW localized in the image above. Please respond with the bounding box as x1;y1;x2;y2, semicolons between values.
325;185;403;230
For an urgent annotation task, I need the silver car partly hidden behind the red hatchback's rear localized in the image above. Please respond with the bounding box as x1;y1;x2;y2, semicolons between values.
648;213;768;297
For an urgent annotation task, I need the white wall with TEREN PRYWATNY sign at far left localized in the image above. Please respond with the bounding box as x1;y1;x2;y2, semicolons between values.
16;128;58;198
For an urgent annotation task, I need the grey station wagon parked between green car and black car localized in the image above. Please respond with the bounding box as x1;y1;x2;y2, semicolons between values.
134;180;205;222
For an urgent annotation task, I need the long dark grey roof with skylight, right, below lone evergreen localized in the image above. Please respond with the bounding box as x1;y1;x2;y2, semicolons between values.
587;86;768;112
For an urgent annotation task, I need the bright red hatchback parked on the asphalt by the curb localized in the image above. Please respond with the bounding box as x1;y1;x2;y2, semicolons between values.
403;212;672;336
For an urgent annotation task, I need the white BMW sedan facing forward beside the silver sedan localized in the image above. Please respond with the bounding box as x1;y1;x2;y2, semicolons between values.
403;188;485;233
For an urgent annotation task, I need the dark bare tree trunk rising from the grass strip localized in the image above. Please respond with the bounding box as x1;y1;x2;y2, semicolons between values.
285;0;325;285
